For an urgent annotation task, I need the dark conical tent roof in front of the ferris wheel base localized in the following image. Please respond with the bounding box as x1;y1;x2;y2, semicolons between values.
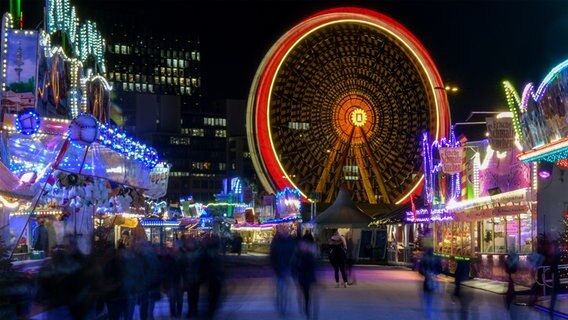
311;185;372;228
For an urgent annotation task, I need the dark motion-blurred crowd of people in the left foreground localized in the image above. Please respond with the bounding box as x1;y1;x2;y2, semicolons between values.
29;234;224;320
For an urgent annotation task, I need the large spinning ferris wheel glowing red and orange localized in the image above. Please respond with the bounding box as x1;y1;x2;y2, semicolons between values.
247;8;449;203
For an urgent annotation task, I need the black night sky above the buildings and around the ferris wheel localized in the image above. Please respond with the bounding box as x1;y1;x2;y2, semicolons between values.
8;0;568;140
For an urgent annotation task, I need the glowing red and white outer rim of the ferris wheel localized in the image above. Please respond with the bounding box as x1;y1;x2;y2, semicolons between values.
247;7;449;204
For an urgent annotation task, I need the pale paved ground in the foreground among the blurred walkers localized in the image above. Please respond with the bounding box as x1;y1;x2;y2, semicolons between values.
34;257;568;320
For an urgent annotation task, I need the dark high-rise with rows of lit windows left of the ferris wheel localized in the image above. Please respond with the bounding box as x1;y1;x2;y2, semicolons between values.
102;24;227;202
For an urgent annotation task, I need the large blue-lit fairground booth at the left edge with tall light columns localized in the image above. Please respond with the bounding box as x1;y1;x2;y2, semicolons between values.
0;0;161;260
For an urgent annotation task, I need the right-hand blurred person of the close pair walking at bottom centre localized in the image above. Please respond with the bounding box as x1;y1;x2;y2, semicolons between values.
294;230;317;319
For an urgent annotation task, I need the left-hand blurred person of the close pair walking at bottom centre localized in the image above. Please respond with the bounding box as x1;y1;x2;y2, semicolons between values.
269;227;296;315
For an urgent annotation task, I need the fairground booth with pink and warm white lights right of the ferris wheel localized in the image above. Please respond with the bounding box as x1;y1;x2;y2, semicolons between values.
412;125;537;283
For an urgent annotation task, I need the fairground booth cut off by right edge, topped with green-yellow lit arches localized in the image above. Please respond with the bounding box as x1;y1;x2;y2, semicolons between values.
505;60;568;287
